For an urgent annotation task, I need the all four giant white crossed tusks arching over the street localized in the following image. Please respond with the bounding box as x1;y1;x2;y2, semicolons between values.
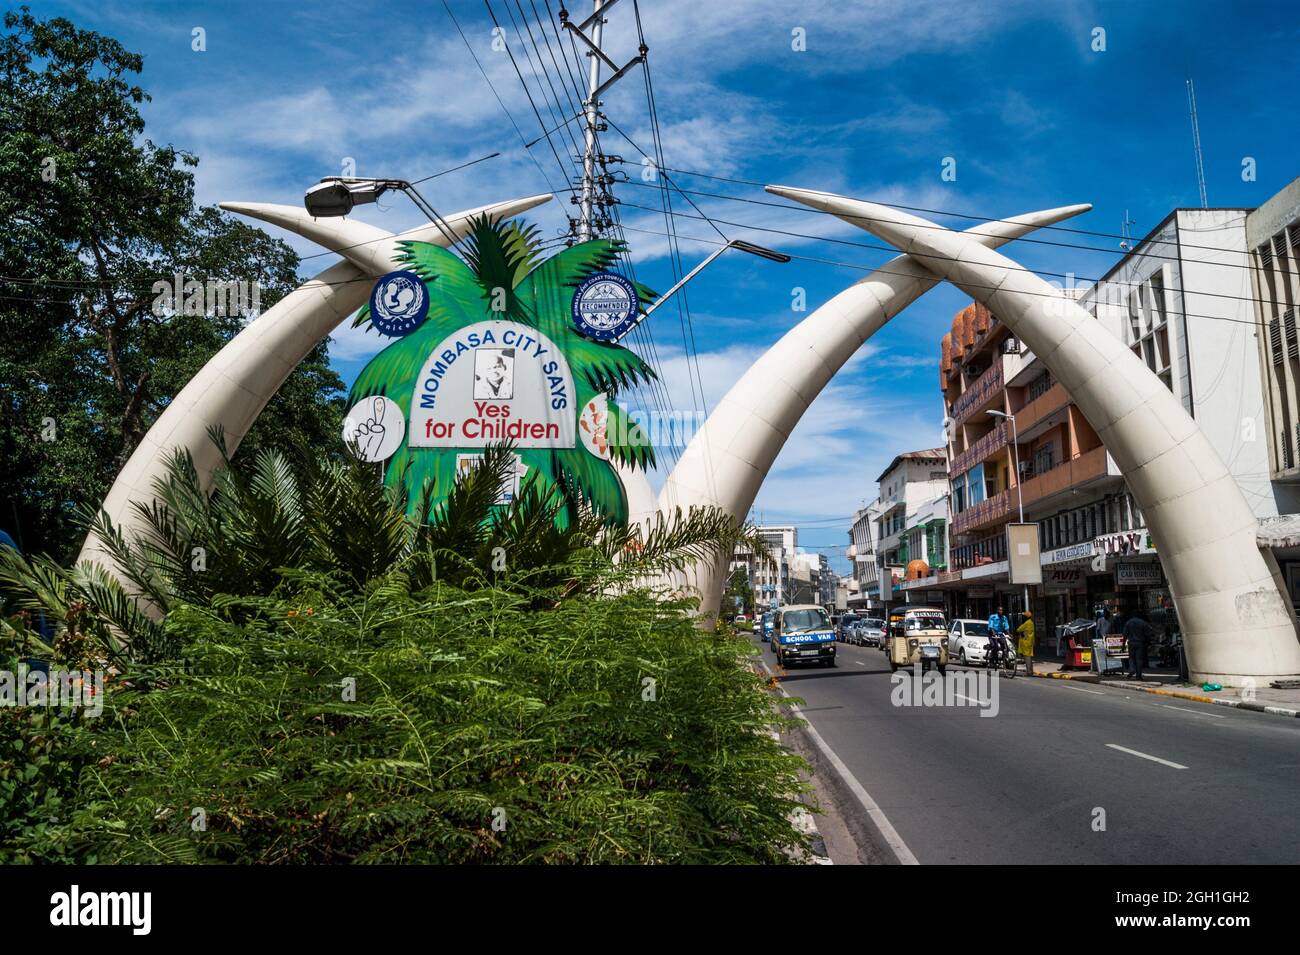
79;186;1300;686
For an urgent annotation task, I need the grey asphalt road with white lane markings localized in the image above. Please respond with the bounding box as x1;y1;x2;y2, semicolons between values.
763;634;1300;867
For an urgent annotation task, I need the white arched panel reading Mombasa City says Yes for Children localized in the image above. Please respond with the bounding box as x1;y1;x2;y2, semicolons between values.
407;321;576;448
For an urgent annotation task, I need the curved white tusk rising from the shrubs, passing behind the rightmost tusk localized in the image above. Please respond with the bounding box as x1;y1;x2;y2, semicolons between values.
659;194;1092;628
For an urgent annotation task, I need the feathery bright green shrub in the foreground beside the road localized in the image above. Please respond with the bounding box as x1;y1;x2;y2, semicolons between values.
65;574;805;863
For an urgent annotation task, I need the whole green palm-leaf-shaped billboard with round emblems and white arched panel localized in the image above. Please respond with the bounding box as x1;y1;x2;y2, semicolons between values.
350;217;657;524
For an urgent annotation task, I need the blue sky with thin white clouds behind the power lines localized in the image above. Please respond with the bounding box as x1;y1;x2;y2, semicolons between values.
31;0;1300;567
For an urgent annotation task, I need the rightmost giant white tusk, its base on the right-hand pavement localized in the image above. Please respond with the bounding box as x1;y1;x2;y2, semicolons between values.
789;191;1300;686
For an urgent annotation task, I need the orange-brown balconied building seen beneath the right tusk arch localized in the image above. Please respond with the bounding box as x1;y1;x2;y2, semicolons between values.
940;304;1162;642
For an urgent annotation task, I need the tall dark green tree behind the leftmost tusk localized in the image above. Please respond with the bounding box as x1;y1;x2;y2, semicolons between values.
0;8;342;557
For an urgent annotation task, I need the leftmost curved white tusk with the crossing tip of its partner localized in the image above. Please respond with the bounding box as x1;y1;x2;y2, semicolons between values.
78;195;551;589
